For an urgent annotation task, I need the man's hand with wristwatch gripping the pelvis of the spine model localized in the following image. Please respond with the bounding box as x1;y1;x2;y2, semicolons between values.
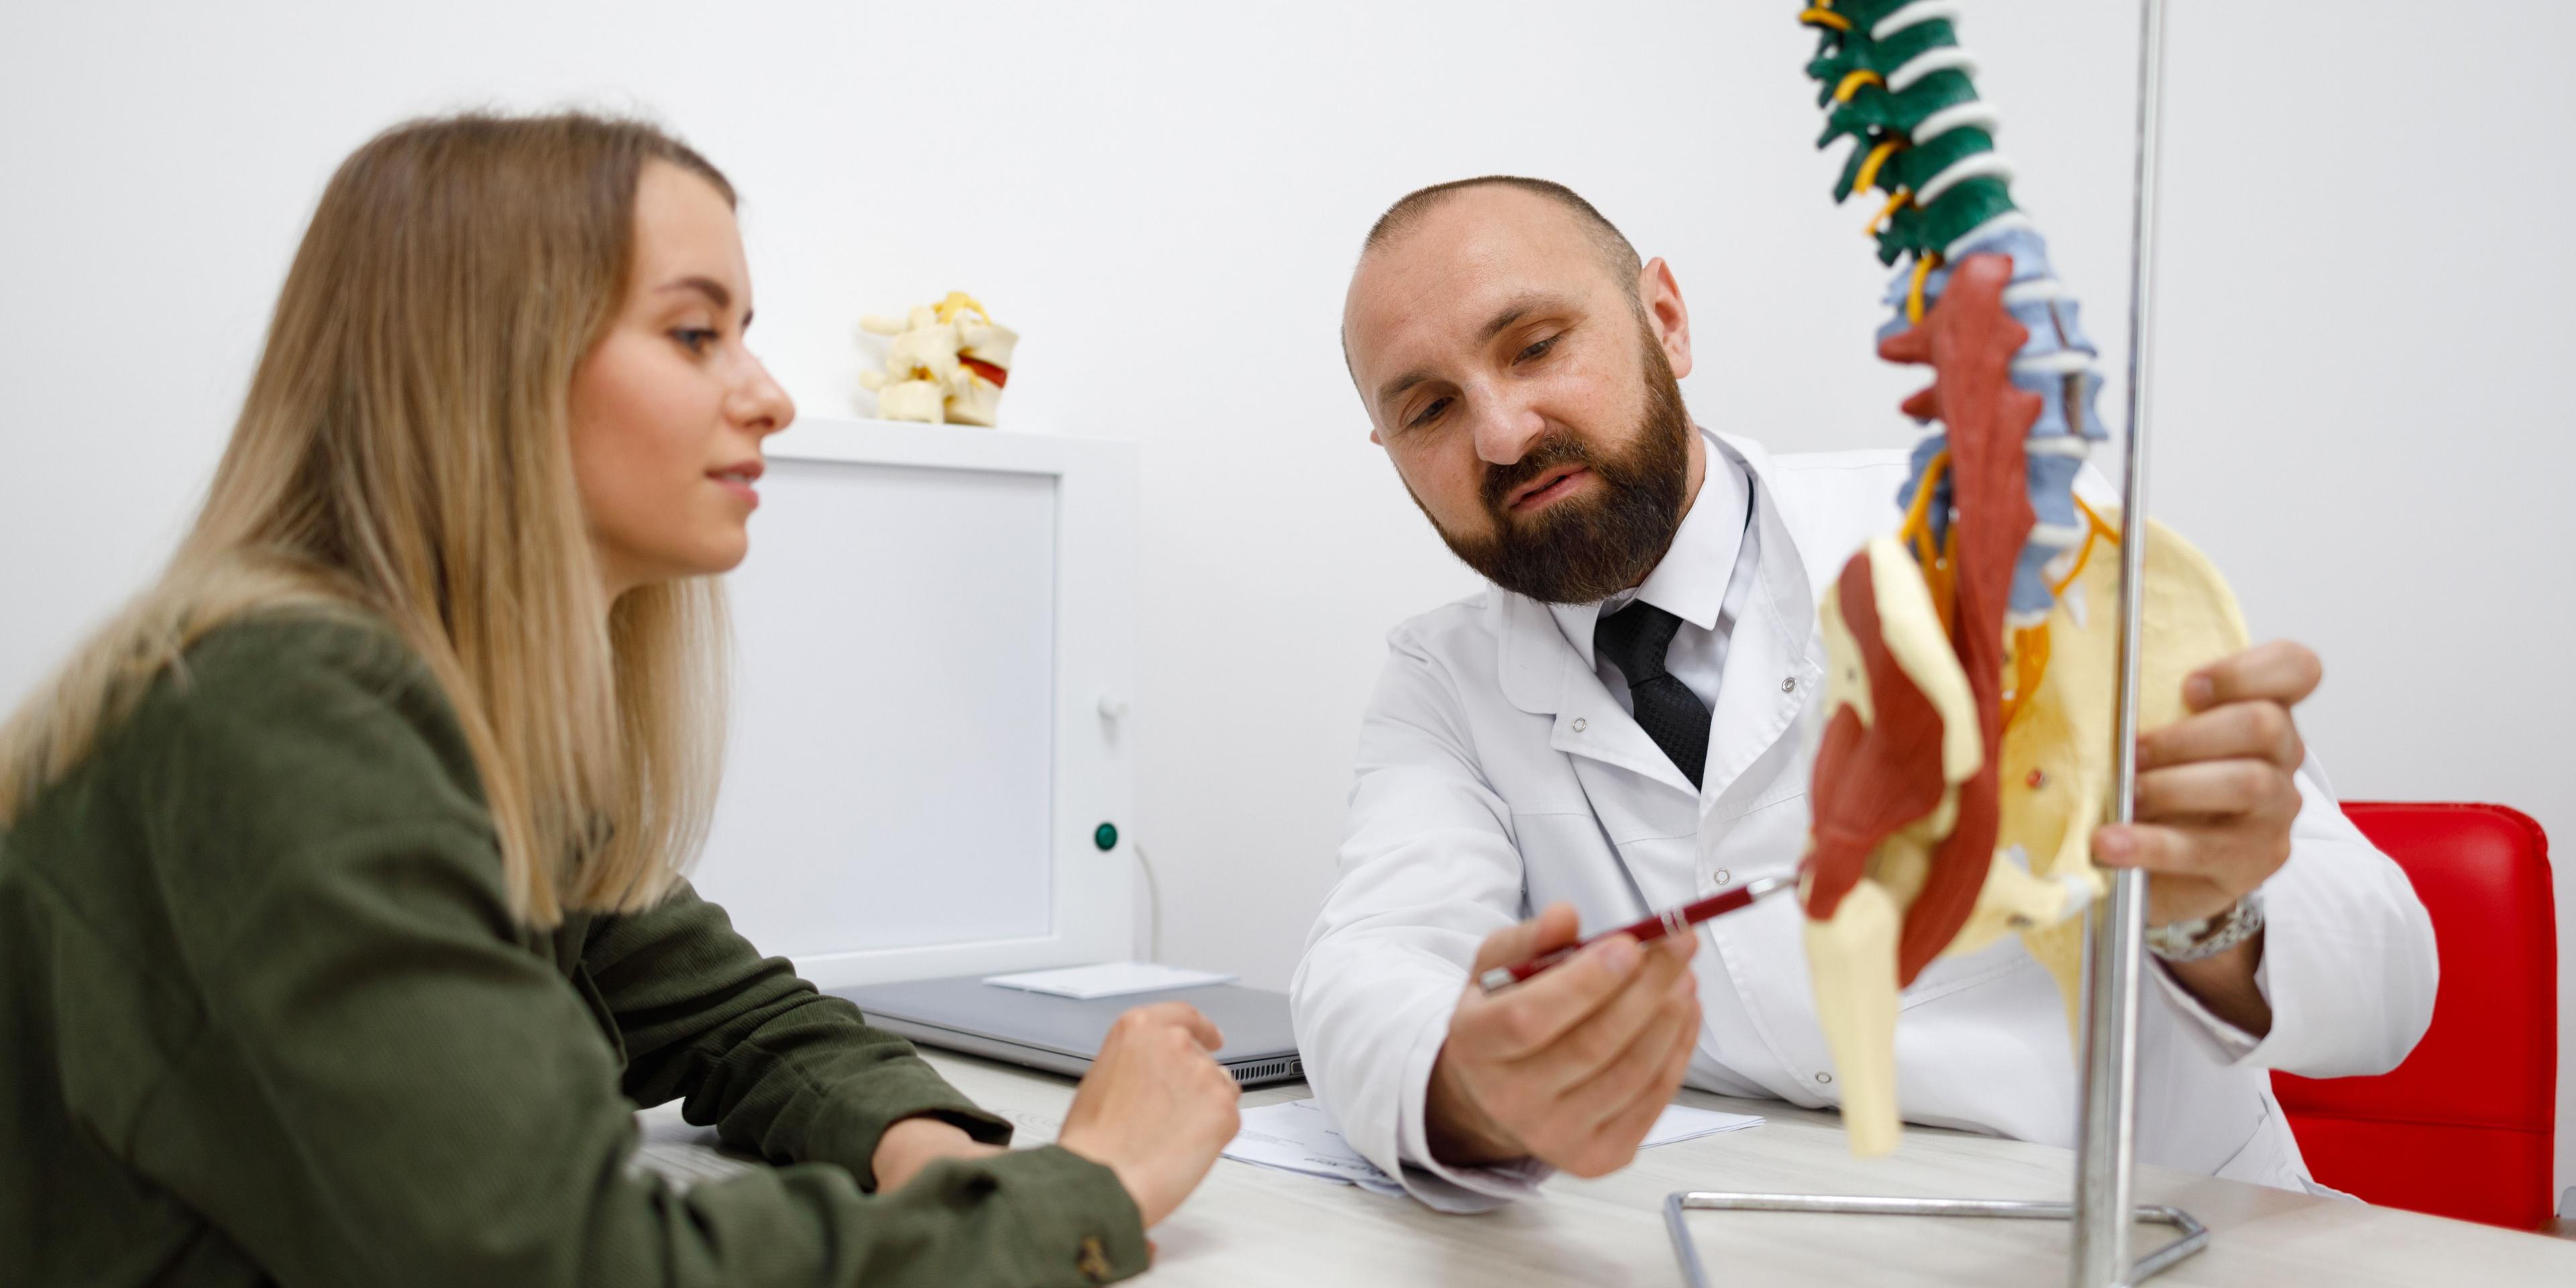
2094;639;2324;925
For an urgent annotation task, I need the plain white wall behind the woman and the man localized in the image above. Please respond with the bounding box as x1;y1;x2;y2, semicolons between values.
0;0;2576;1195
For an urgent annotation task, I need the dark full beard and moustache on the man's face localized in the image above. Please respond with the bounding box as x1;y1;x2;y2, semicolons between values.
1414;322;1695;603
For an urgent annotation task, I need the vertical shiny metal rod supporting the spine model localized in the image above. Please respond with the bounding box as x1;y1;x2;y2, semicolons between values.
2069;0;2164;1288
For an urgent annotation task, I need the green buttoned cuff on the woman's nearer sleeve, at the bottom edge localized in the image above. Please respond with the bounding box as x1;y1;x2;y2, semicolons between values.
943;1144;1151;1288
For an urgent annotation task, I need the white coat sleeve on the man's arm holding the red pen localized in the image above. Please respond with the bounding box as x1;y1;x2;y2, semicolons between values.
1291;631;1551;1211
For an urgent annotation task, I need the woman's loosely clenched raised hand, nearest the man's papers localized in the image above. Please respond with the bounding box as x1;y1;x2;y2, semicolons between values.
1056;1002;1242;1226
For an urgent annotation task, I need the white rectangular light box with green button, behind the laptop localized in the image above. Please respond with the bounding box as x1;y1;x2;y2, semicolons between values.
690;420;1136;989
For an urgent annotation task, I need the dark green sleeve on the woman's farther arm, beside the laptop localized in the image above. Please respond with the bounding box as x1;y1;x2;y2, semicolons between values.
582;883;1010;1190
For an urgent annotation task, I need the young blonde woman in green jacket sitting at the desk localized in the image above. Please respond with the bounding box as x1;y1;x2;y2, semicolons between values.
0;116;1234;1288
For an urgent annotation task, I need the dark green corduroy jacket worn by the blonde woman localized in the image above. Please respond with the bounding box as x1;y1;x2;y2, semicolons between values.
0;616;1146;1288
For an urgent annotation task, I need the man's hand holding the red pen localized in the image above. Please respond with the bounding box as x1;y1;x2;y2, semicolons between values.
1427;904;1700;1177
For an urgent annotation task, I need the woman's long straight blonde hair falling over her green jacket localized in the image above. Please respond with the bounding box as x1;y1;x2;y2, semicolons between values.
0;113;734;927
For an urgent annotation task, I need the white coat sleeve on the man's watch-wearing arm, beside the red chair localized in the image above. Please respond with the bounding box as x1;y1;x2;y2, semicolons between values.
2149;755;2442;1077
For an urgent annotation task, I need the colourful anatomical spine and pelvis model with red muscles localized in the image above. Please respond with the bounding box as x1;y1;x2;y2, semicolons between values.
1798;0;2246;1154
